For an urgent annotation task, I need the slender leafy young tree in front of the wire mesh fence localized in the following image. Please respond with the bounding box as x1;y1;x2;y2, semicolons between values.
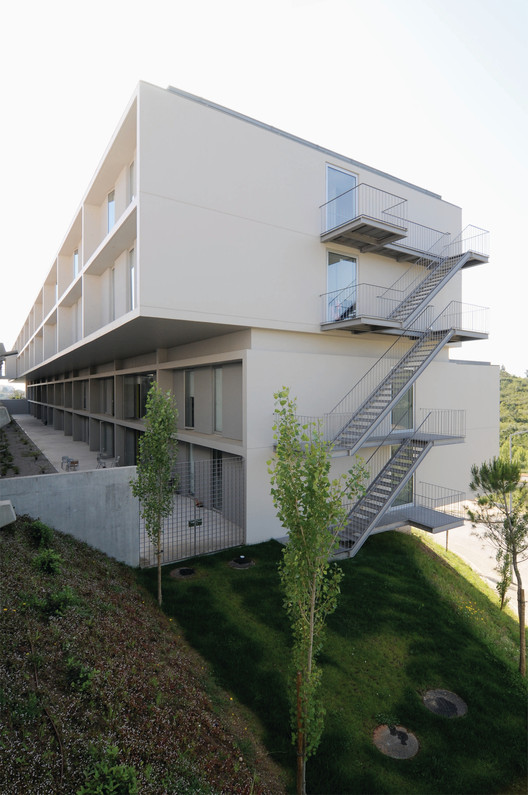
130;382;178;605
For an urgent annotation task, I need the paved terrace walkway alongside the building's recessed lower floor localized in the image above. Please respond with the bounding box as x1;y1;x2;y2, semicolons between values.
11;414;98;472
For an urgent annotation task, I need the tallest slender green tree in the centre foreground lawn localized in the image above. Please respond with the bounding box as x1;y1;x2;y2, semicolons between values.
268;388;365;795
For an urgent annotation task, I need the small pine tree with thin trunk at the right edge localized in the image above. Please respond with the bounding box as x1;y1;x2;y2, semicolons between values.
468;458;528;676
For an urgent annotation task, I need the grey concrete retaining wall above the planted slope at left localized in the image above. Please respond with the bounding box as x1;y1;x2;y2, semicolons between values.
0;466;139;566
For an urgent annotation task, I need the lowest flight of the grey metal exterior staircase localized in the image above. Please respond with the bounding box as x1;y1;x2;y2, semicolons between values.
337;438;433;557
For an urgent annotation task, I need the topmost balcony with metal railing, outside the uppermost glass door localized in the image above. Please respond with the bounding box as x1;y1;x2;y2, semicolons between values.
321;183;407;251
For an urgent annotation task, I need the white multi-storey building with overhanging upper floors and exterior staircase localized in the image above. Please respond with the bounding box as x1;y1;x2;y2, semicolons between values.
7;83;499;550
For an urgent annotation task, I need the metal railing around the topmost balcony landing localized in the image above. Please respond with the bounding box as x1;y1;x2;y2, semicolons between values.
320;182;407;234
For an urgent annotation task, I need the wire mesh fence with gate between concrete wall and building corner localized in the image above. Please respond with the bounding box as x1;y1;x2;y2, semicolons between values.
139;455;246;567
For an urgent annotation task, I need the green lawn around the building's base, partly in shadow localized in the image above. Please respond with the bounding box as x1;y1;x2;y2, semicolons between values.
138;533;526;795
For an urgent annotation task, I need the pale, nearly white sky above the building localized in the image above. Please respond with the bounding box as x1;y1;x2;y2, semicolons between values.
0;0;528;375
